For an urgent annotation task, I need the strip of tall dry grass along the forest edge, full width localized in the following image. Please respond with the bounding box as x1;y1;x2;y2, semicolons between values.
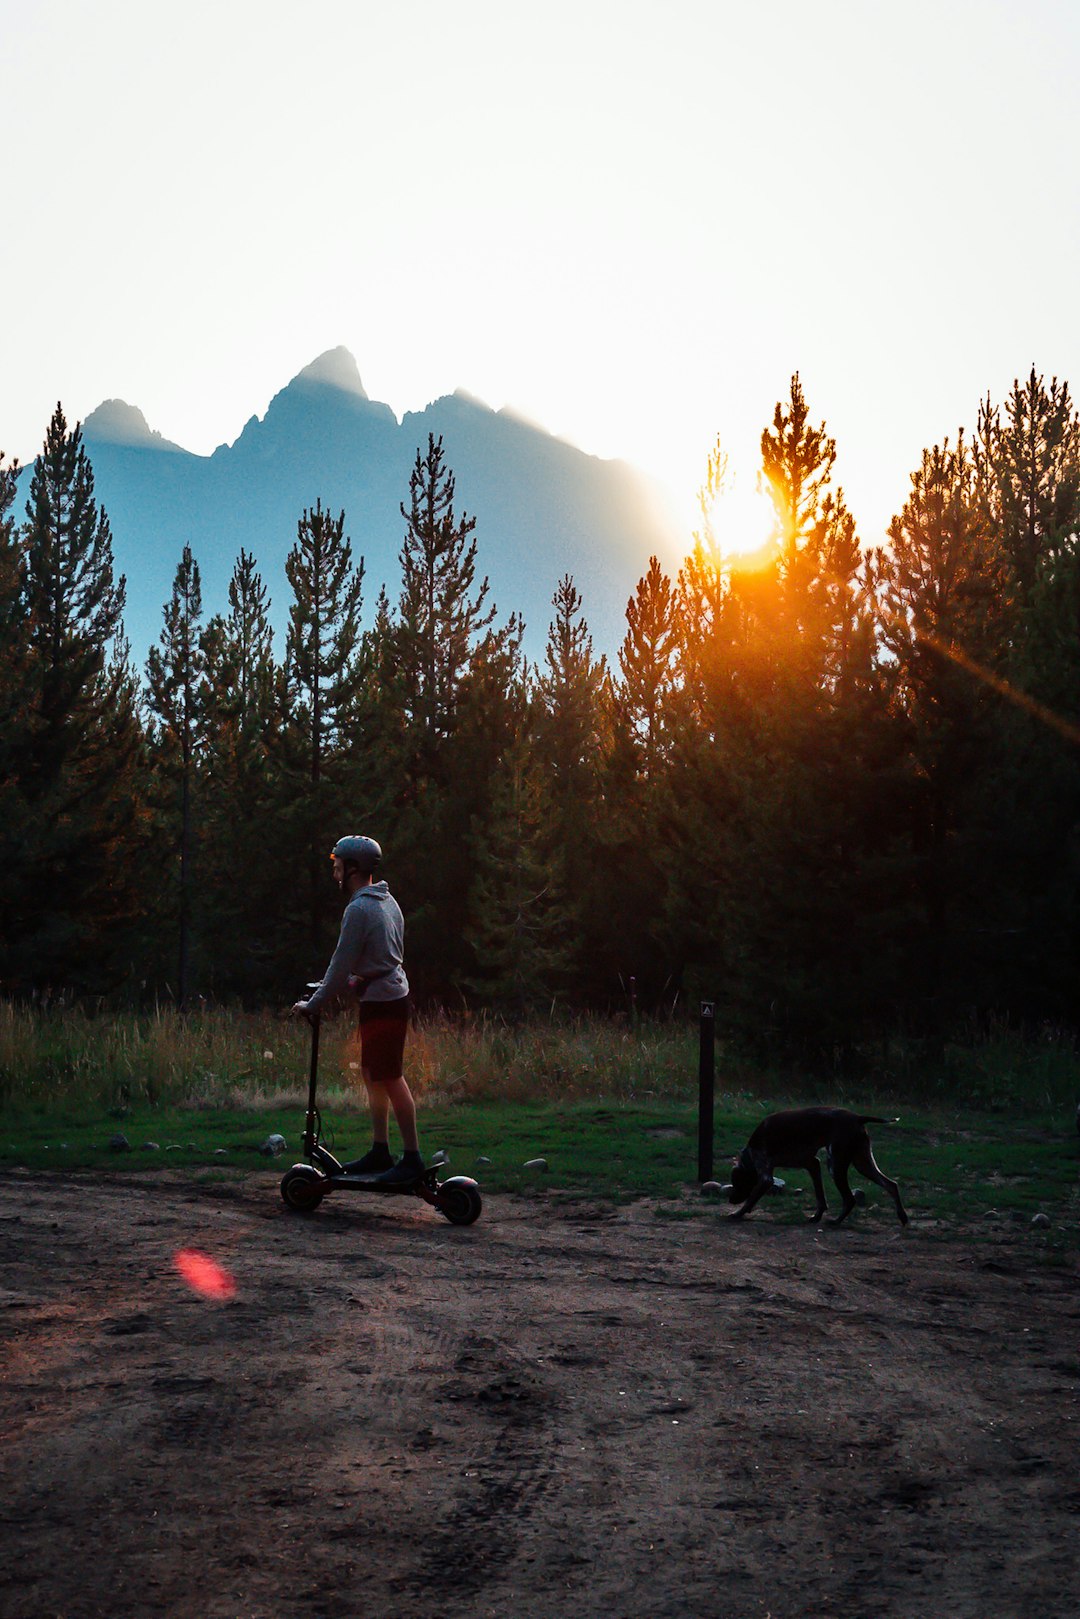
0;1002;1080;1114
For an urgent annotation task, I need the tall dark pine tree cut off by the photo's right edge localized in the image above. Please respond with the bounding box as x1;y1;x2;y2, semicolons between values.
972;368;1080;1020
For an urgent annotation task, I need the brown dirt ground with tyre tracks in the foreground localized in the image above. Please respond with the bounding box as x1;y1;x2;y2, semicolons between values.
0;1174;1080;1619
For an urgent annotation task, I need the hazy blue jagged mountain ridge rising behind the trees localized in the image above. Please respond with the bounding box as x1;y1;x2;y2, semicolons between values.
63;348;682;662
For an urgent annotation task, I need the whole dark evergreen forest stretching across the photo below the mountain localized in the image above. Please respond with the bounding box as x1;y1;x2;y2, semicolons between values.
0;371;1080;1064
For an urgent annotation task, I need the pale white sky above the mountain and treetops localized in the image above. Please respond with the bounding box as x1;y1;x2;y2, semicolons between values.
0;0;1080;542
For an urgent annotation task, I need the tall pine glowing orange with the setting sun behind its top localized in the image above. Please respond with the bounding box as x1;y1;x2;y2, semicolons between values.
656;386;891;1060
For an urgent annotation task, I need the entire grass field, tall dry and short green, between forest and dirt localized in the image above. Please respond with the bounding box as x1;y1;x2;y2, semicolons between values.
0;1005;1080;1251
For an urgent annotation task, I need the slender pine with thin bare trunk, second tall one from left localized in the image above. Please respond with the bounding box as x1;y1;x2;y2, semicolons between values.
146;546;206;1007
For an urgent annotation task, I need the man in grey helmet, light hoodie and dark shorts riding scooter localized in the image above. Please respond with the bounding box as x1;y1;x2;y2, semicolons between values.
293;837;424;1185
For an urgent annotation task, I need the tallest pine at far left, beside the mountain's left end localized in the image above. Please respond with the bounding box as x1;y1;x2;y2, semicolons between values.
10;406;141;988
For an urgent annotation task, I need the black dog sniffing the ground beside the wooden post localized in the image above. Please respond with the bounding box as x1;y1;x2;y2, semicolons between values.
730;1107;907;1226
